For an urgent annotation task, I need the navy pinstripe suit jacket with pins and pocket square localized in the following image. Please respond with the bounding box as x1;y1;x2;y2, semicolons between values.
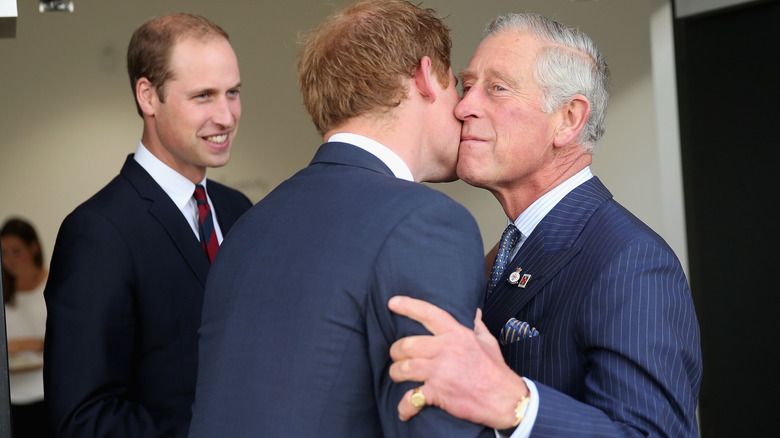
484;177;702;437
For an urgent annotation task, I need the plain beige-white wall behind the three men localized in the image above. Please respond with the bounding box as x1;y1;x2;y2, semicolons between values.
0;0;685;272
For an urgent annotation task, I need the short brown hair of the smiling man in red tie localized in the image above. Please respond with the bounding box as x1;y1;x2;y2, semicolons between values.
127;12;229;116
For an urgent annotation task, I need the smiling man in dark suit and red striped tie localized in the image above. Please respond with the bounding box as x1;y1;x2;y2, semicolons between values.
44;14;251;438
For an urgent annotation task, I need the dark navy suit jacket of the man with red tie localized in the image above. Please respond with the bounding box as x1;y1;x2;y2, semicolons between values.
44;155;251;438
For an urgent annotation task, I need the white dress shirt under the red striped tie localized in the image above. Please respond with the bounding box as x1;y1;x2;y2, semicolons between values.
134;142;222;244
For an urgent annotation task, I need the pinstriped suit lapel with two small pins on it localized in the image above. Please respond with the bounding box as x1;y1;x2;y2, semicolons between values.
483;177;612;336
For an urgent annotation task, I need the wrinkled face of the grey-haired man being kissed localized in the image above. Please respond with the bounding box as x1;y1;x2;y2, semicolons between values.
455;31;555;191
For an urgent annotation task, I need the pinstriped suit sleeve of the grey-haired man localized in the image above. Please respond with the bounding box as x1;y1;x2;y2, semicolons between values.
533;242;701;437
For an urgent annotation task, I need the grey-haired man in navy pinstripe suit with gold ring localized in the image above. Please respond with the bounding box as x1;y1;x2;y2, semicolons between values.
389;14;702;437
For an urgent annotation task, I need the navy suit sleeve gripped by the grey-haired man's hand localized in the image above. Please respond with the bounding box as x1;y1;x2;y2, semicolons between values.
367;198;494;438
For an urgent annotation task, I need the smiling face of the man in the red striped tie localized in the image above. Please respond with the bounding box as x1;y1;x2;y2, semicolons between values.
145;38;241;182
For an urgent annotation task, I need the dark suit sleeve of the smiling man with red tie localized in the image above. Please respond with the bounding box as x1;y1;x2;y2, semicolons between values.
44;210;186;438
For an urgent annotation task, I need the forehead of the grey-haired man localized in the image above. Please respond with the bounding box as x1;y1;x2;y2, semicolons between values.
460;30;543;80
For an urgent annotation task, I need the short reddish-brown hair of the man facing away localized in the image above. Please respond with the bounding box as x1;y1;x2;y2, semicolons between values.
298;0;452;135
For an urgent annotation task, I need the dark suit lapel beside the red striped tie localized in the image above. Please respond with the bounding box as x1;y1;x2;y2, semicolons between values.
121;155;210;286
